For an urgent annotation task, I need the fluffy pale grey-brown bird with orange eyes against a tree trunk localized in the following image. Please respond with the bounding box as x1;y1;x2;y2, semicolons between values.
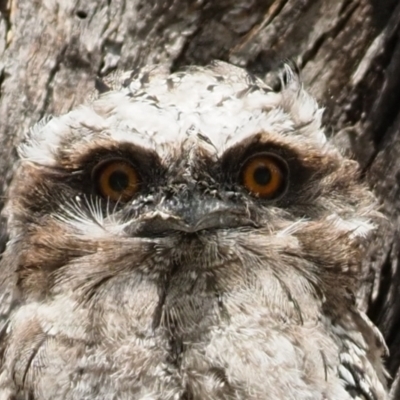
0;61;388;400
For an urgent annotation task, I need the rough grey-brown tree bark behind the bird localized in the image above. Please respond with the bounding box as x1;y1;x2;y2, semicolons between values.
0;0;400;398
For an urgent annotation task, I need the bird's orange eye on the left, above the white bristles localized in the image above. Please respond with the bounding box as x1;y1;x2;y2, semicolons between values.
95;160;139;201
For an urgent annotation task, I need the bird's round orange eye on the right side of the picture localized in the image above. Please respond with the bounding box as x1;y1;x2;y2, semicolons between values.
241;153;288;199
